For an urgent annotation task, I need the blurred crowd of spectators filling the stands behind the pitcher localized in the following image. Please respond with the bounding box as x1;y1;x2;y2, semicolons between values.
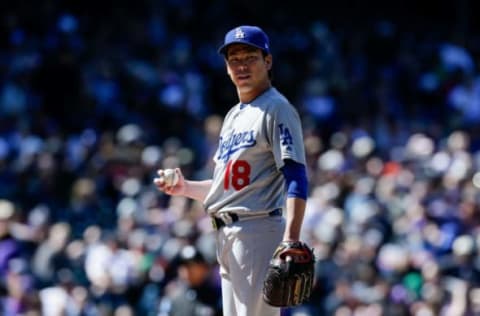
0;0;480;316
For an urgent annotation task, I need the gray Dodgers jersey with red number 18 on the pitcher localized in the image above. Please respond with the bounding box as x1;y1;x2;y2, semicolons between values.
204;88;305;214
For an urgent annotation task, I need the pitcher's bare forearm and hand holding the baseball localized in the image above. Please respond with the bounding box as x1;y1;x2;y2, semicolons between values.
153;168;212;203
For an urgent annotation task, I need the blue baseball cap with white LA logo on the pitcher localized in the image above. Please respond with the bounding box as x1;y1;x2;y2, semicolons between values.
218;25;270;55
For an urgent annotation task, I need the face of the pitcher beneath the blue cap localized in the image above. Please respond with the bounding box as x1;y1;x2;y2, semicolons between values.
226;44;272;97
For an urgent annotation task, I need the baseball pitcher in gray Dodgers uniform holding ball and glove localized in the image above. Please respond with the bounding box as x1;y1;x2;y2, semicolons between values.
154;25;314;316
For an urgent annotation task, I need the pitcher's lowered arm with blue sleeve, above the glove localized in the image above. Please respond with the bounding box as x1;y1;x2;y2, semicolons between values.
280;159;308;241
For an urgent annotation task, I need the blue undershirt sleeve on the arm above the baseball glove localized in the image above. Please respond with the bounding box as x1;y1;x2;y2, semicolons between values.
280;159;308;200
